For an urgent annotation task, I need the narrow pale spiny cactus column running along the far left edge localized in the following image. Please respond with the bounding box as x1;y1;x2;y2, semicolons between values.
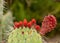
0;0;4;43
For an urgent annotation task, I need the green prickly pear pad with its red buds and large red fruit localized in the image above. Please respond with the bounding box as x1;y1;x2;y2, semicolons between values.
8;14;57;43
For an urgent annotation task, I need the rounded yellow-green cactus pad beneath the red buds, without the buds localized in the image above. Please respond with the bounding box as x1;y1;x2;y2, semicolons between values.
8;27;42;43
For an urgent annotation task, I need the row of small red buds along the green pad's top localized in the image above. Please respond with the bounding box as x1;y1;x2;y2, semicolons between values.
14;19;40;31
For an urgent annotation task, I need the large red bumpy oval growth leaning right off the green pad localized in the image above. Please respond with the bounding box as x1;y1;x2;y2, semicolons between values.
40;15;57;35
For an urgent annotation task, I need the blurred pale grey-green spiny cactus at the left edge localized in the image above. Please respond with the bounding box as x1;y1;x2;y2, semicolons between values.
0;0;13;43
